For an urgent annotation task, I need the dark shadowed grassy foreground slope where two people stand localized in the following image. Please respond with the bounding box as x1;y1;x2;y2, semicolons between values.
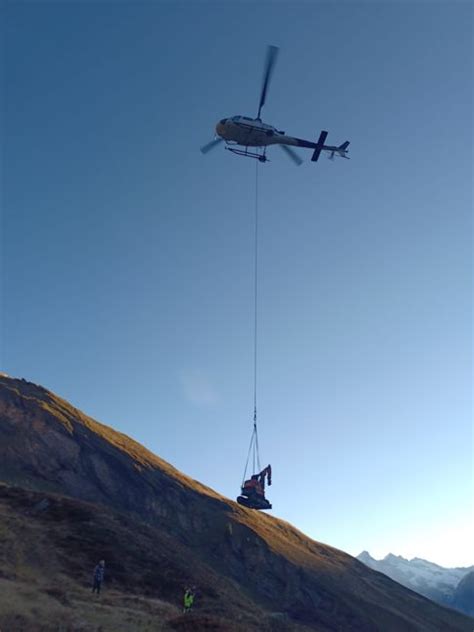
0;485;305;632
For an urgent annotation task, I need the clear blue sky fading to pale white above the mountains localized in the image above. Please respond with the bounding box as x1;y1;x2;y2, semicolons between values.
1;1;474;565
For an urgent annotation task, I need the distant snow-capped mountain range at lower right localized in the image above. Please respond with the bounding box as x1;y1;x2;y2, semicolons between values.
357;551;474;615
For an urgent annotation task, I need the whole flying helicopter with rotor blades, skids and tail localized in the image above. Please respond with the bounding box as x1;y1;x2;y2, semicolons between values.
201;46;349;165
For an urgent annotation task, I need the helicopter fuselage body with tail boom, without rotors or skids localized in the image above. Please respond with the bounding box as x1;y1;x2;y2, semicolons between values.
216;116;316;148
